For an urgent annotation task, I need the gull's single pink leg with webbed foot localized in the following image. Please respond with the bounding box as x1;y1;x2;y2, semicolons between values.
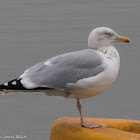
77;99;101;128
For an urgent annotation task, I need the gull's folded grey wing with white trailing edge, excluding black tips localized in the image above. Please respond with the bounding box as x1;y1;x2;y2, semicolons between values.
20;49;105;89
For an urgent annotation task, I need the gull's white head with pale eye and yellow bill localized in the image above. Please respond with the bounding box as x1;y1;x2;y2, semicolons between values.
88;27;130;49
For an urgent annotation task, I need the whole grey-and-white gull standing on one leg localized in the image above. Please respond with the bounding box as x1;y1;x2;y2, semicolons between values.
0;27;130;128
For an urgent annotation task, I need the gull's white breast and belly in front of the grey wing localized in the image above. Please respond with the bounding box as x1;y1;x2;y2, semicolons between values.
69;46;120;99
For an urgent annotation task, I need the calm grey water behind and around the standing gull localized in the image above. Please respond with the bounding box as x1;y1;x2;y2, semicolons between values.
0;0;140;140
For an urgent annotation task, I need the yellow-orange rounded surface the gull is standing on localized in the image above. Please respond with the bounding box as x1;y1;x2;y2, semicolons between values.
50;118;140;140
